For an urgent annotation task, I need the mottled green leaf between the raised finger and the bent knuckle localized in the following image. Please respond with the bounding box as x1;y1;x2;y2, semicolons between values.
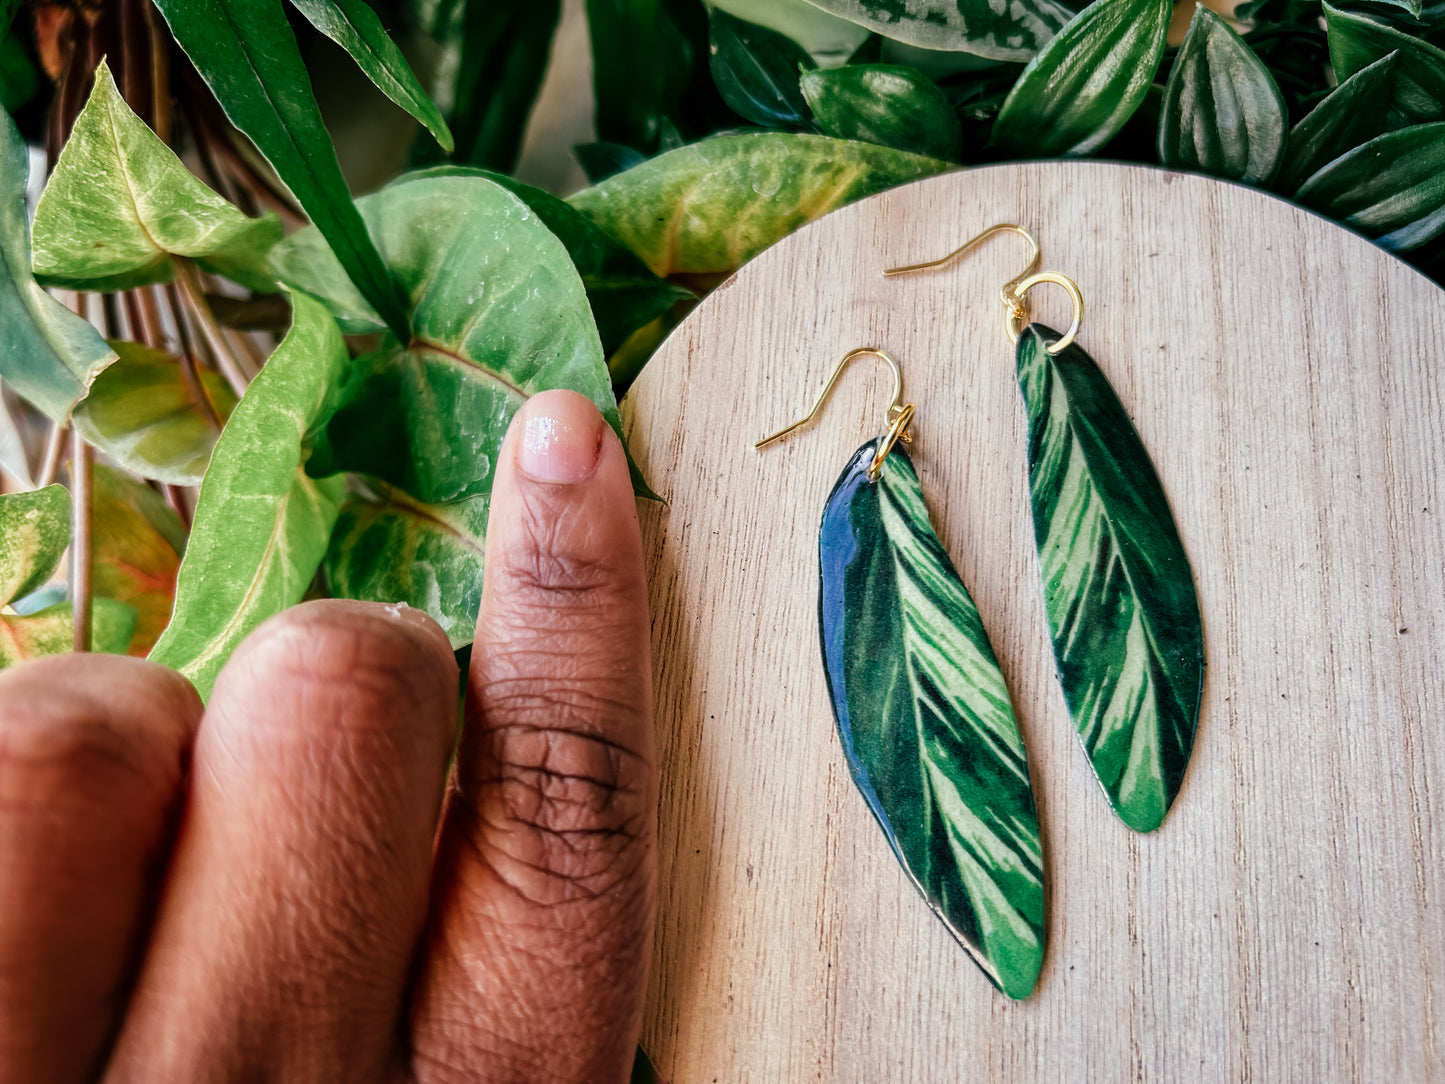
325;484;491;648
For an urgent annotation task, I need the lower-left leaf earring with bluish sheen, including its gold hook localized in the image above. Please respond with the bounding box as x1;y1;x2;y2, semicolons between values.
757;347;1045;999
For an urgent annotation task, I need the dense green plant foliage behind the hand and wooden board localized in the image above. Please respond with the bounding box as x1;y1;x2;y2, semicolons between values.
0;0;1445;694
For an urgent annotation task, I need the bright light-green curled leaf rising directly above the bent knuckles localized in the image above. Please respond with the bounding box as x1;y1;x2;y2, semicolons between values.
150;293;347;698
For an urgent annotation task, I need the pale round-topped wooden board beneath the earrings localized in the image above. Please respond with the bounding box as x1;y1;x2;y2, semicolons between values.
624;162;1445;1084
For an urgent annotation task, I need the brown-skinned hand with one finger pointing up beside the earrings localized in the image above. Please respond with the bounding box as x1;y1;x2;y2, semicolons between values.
0;392;656;1084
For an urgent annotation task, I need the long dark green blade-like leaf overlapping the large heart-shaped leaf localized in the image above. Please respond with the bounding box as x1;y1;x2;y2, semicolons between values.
156;0;406;337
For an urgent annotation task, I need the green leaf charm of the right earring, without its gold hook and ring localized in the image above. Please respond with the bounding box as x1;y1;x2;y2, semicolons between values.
1019;324;1204;833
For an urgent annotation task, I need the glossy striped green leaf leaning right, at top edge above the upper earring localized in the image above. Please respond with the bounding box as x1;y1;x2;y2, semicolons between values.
993;0;1173;158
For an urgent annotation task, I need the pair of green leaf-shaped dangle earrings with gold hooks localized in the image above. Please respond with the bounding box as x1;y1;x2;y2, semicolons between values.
757;225;1204;999
